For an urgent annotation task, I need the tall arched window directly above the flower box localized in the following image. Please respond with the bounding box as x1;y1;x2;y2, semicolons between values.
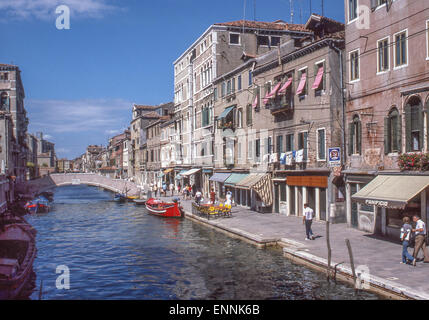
405;96;423;152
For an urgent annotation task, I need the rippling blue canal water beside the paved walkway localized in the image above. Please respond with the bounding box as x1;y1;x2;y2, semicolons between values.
24;186;378;299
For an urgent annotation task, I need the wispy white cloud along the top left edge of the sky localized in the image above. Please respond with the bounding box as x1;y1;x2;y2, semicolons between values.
0;0;119;20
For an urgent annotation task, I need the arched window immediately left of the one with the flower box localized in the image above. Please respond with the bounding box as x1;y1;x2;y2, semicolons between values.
384;107;402;154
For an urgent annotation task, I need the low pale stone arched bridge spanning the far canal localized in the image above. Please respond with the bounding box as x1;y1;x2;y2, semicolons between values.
22;173;140;196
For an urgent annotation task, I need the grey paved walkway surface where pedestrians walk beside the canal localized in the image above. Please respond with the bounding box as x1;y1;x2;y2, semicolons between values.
160;192;429;299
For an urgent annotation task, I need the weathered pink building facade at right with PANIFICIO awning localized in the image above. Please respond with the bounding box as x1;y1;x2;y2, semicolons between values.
345;0;429;237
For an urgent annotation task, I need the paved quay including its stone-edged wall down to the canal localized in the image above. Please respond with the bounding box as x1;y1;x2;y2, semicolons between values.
178;201;429;300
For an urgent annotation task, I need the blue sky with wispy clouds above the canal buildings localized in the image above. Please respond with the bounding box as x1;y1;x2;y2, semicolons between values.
0;0;344;158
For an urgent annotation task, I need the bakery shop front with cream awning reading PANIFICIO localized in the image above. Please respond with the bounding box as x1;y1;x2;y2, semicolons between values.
351;173;429;239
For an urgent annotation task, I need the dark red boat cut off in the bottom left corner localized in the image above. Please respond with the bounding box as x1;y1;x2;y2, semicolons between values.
0;223;36;299
